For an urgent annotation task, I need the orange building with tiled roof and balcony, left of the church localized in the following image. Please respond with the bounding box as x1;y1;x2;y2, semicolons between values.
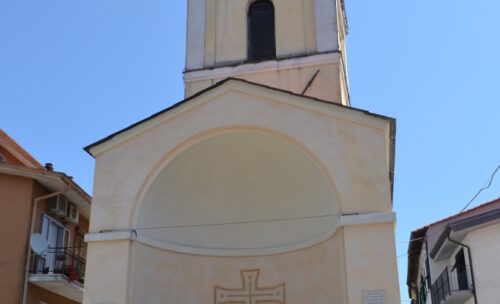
0;129;90;304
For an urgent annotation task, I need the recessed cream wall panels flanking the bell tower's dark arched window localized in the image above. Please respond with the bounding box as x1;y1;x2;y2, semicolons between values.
201;0;316;67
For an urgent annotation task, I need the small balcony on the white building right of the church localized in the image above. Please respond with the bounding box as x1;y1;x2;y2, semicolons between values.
431;266;474;304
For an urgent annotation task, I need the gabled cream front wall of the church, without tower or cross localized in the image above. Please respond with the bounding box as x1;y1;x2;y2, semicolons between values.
84;80;400;304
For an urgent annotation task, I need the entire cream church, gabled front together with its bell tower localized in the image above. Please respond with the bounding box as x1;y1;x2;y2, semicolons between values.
83;0;400;304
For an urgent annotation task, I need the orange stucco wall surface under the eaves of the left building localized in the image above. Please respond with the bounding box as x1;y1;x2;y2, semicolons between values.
0;170;88;304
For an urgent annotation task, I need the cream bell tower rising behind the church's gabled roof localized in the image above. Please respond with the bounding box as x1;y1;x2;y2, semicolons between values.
184;0;350;106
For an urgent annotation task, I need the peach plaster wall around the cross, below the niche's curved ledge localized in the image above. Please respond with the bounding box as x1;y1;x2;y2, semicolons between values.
131;235;346;304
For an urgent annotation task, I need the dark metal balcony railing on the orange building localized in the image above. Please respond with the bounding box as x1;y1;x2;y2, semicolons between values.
30;248;85;284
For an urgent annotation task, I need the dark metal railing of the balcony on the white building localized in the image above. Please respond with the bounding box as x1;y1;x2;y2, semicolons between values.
431;266;473;304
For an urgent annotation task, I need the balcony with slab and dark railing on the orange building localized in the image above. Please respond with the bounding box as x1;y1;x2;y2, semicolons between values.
29;248;85;303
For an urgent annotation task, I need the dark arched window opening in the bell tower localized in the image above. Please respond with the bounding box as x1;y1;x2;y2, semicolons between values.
248;1;276;61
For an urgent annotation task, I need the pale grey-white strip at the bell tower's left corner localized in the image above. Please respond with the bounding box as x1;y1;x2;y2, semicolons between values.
186;0;205;70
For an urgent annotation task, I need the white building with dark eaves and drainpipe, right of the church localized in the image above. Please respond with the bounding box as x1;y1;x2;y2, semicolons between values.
407;198;500;304
